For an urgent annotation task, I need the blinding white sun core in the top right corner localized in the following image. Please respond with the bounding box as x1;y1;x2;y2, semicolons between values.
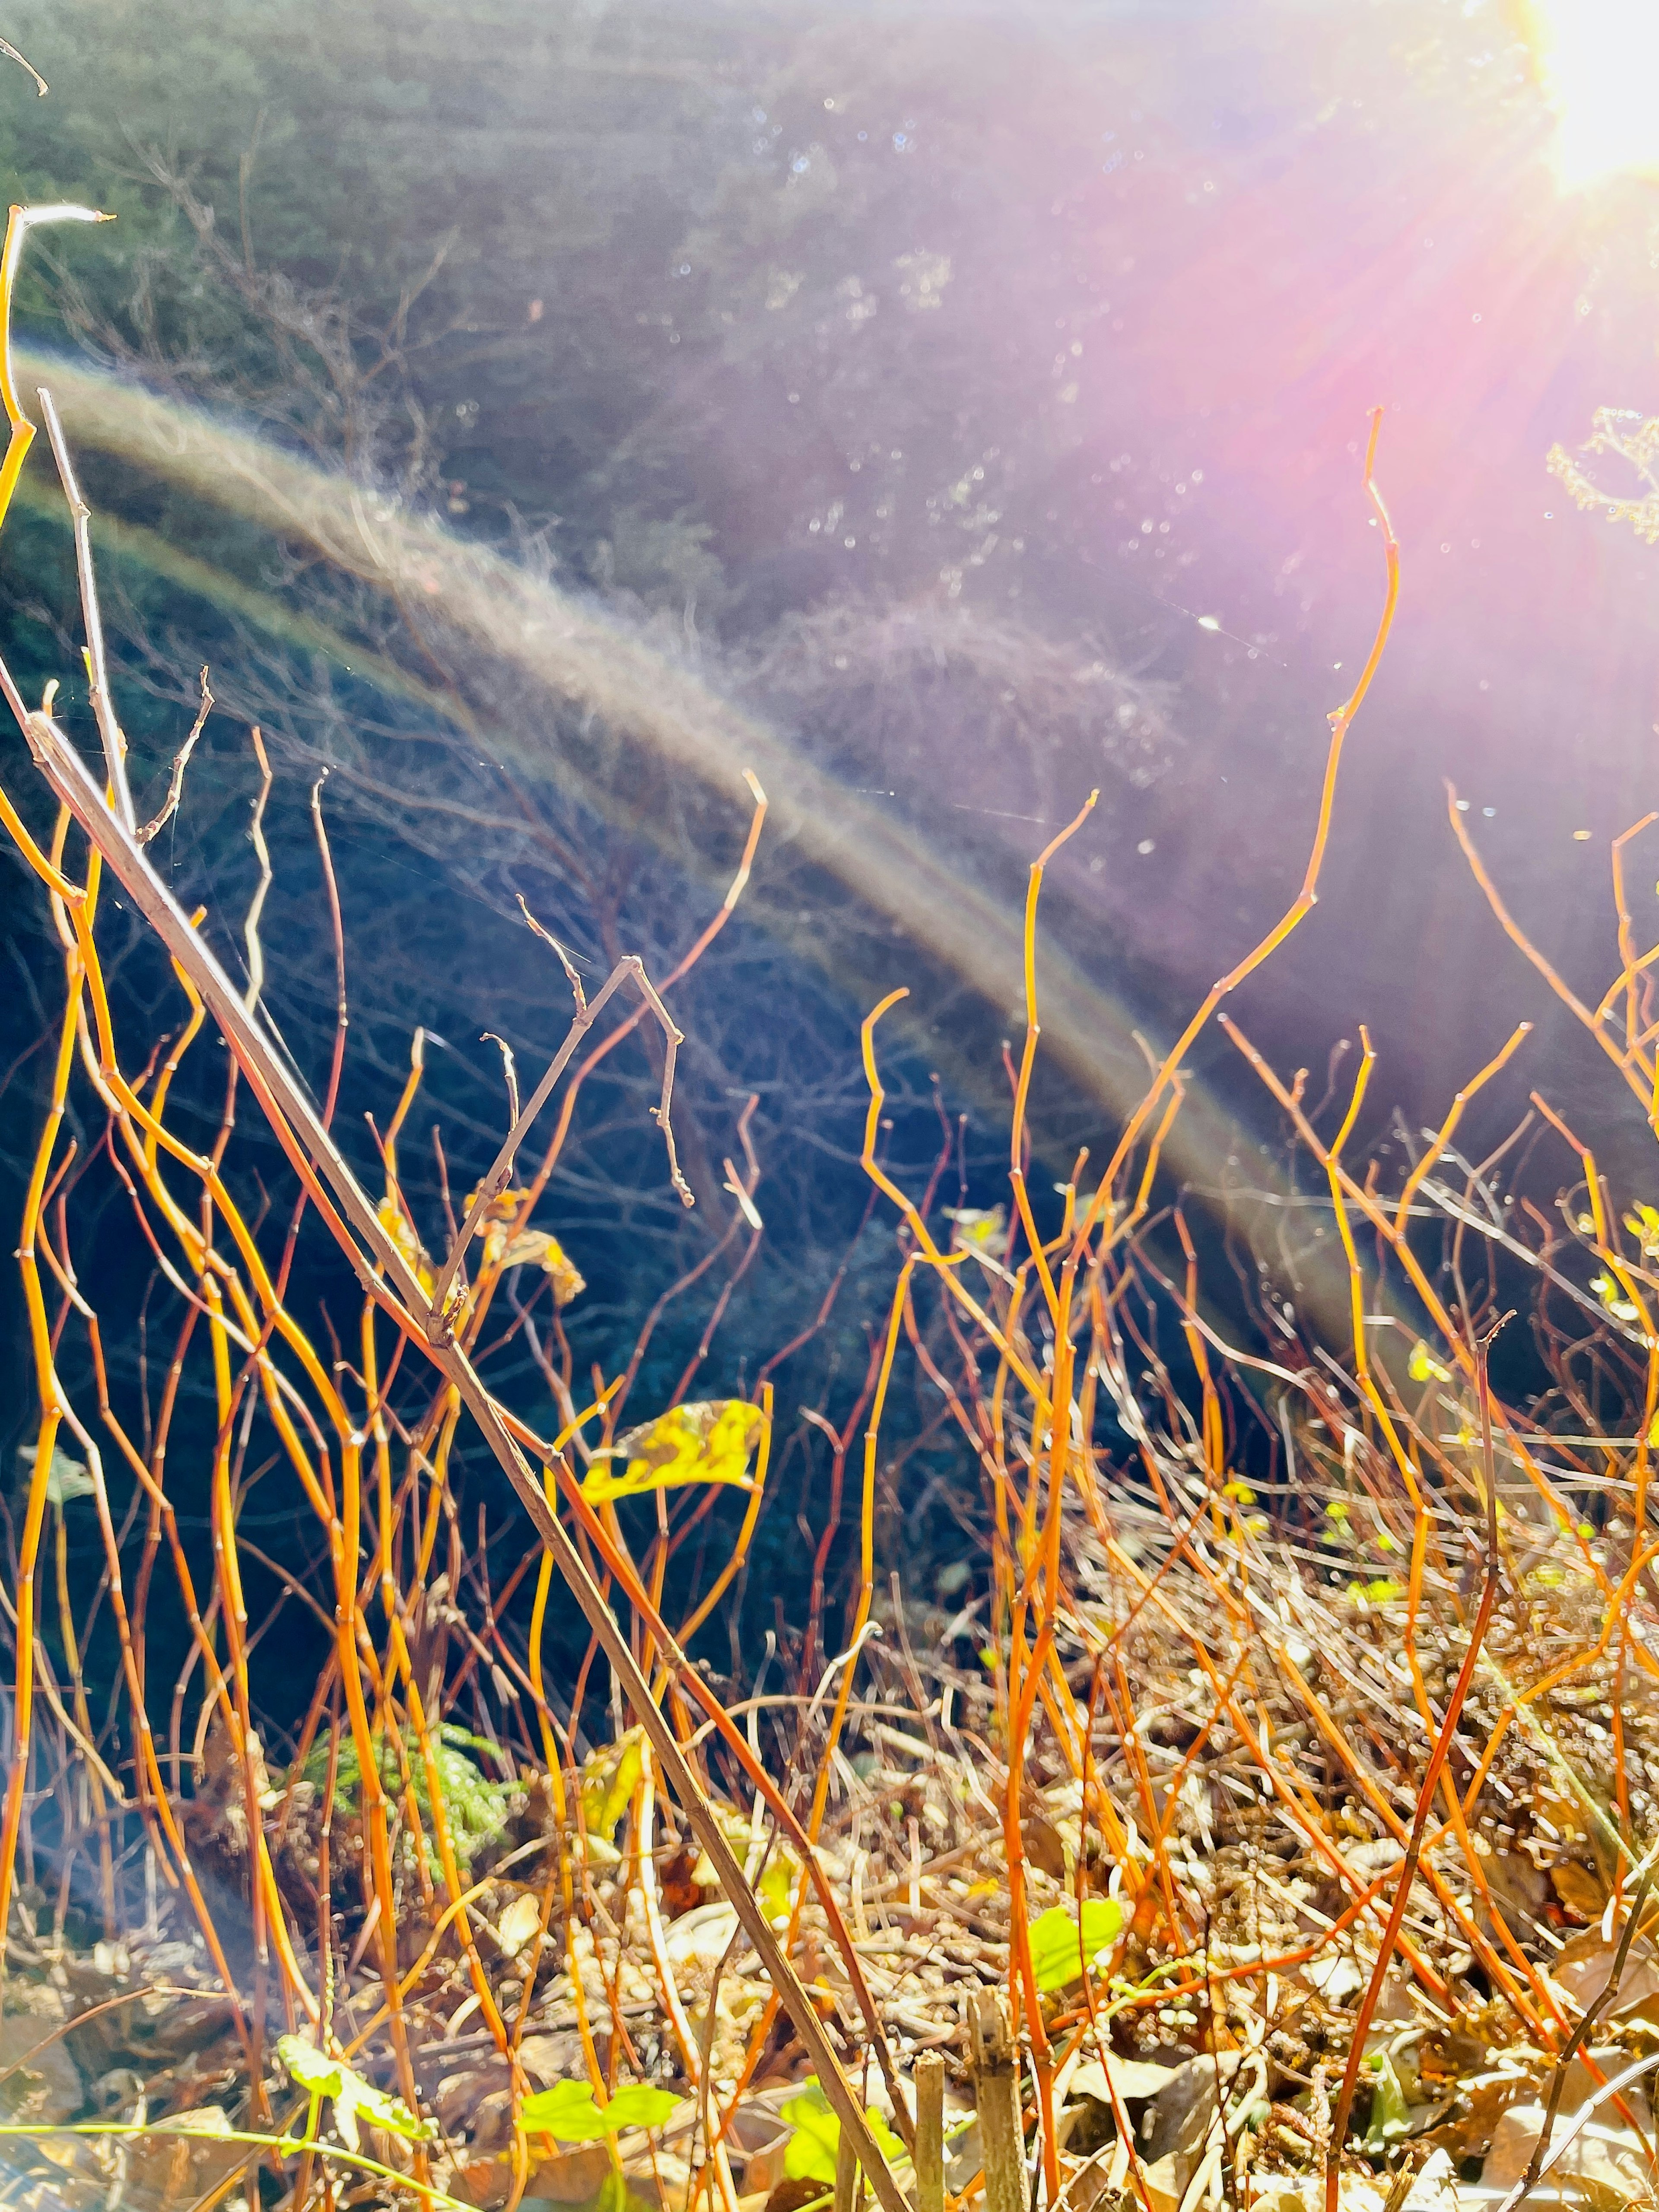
1526;0;1659;192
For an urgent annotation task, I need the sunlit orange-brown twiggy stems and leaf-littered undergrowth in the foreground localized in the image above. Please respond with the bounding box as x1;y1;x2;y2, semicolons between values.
0;143;1659;2212
